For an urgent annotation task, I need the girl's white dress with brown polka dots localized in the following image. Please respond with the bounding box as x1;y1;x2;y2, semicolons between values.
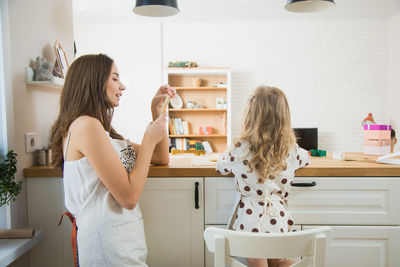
216;142;310;233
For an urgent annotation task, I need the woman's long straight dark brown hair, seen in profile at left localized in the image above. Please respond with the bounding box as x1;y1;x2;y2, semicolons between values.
50;54;123;167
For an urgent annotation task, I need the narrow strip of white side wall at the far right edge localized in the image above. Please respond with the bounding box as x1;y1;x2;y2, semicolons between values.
387;13;400;151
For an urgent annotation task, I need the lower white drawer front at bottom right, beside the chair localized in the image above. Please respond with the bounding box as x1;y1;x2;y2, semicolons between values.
303;225;400;267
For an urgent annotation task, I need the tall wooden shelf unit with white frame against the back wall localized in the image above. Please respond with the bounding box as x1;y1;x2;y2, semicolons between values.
165;68;231;153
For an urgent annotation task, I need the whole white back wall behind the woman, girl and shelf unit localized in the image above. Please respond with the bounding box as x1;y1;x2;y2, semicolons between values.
75;17;394;151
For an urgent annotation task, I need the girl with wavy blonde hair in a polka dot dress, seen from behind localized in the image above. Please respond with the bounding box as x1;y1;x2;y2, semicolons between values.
216;86;310;267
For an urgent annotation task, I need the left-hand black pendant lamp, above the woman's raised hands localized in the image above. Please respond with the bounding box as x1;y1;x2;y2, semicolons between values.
133;0;179;17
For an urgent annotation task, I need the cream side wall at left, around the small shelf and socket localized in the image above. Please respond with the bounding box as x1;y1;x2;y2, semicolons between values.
6;0;73;266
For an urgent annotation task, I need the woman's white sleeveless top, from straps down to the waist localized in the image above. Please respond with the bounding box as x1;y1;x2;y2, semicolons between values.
64;132;141;233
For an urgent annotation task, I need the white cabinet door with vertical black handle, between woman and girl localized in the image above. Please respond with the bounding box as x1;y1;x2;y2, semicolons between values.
140;178;204;267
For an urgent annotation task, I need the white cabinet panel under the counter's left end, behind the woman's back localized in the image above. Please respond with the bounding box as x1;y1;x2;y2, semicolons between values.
26;178;74;267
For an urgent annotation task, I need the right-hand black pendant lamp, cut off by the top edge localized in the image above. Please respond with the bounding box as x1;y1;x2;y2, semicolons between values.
285;0;335;13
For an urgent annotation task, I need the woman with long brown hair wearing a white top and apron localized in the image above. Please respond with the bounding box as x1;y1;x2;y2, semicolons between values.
51;54;175;267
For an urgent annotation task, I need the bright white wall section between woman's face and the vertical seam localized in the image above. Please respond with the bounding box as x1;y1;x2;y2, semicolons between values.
74;22;162;143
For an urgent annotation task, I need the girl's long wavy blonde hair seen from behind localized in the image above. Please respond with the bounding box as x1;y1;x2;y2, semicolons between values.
235;86;296;183
